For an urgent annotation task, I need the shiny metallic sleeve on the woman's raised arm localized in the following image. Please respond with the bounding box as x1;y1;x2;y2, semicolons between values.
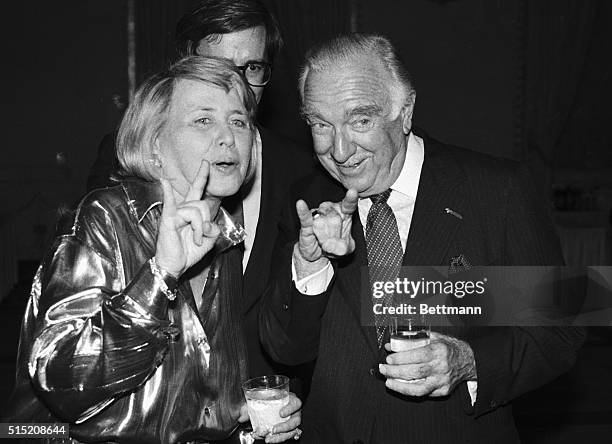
26;193;169;423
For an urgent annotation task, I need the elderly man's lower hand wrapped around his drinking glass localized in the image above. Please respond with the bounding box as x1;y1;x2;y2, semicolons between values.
380;332;476;397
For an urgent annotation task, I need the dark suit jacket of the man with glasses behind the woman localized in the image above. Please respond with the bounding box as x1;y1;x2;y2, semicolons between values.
87;127;315;384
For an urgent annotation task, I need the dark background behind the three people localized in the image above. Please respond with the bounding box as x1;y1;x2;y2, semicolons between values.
0;0;612;442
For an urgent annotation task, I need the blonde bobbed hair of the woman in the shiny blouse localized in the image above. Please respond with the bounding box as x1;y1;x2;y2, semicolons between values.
116;56;257;181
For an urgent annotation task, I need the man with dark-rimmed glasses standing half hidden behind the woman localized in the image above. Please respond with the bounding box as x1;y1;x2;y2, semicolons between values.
87;0;313;396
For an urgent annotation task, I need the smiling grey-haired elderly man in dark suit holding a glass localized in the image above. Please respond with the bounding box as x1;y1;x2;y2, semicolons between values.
260;35;583;443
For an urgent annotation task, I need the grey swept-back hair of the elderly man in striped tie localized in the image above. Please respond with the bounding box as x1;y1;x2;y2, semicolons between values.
298;33;415;113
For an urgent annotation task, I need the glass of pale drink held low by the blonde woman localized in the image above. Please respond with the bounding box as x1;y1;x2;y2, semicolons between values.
242;375;289;435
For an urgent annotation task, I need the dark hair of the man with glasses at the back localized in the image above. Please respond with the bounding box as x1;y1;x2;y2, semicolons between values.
175;0;283;64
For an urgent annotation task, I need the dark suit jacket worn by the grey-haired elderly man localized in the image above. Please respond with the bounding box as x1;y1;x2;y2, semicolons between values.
260;134;584;444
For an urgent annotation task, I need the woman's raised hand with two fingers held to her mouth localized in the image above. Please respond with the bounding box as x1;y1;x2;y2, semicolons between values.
155;160;219;278
